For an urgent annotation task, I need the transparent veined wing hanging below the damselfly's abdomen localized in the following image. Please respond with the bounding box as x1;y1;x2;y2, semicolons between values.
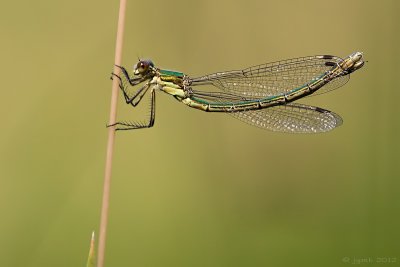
229;103;343;133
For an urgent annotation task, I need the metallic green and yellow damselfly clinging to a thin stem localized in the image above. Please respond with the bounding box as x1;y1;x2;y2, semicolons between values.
110;52;364;133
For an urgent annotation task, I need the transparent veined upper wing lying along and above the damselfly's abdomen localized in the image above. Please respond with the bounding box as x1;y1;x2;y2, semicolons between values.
189;55;349;98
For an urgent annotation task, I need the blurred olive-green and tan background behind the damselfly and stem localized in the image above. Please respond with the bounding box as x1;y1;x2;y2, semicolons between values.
0;0;400;267
